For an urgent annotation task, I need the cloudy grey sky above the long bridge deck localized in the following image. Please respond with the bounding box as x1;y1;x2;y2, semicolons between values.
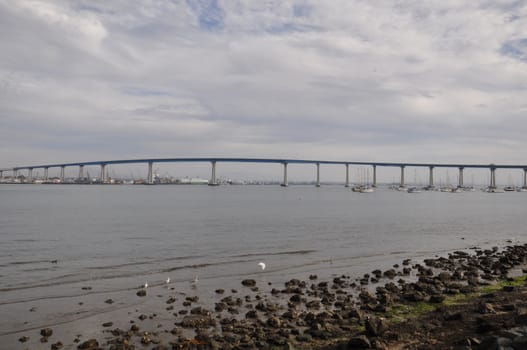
0;0;527;180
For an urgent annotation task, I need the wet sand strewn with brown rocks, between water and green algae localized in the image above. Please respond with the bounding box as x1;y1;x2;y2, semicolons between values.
4;242;527;349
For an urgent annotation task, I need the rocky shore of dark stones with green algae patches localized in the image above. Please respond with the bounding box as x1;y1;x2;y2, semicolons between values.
19;244;527;350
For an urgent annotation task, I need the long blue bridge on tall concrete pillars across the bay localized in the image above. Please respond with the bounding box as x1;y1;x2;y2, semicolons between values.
0;158;527;188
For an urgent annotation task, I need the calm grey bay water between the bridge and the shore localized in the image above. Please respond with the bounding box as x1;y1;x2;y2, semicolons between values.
0;185;527;336
